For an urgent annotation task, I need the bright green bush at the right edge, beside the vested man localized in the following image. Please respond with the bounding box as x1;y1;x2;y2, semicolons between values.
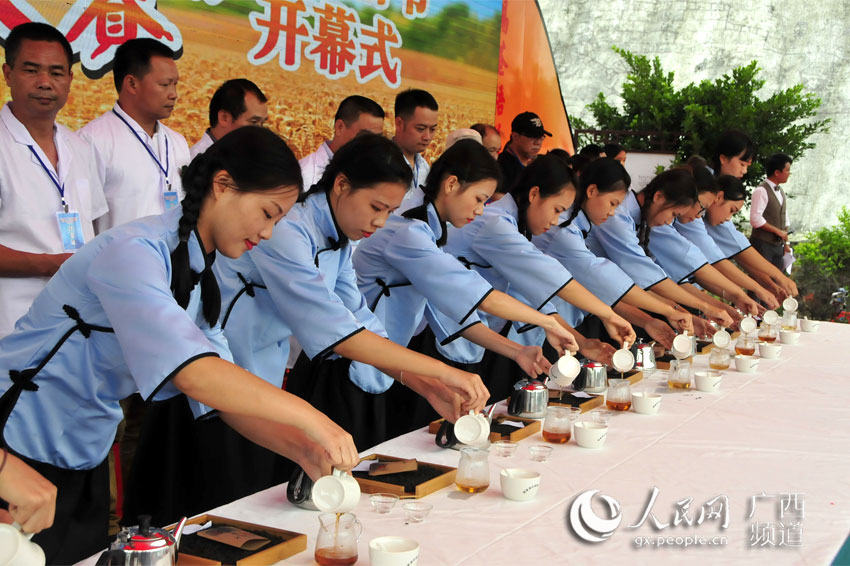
794;207;850;320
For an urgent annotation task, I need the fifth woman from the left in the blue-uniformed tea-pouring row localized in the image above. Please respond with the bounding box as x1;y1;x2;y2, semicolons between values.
532;157;693;348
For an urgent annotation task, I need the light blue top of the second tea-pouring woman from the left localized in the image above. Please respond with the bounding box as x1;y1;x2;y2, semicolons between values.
214;193;392;393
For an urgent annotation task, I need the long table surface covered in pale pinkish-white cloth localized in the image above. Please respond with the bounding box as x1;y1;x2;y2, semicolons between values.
81;323;850;566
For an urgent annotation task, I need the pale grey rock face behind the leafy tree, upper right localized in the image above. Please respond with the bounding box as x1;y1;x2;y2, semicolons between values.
540;0;850;232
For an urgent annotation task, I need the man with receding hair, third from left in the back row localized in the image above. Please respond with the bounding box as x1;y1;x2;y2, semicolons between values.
189;79;269;159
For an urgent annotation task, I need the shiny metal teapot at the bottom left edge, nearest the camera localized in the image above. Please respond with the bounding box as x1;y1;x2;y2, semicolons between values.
97;515;186;566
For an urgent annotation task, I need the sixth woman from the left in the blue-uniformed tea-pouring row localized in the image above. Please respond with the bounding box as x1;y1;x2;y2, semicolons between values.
587;168;732;334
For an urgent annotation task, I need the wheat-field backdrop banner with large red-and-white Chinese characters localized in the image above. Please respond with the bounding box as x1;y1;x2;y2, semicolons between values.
0;0;500;161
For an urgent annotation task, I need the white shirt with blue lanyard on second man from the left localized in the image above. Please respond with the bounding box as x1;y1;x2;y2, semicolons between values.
79;103;191;233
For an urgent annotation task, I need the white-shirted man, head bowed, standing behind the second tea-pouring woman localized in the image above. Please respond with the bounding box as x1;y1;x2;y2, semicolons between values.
298;94;384;191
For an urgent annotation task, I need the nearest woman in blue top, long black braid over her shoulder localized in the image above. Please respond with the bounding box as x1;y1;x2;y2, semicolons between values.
0;127;357;564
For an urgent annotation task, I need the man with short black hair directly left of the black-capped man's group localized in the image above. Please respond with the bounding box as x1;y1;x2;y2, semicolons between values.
393;89;440;189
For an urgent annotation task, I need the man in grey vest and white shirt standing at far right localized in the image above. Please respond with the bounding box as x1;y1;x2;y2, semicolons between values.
750;153;793;271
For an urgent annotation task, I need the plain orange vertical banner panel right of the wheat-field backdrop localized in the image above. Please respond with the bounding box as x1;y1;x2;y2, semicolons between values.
496;0;575;154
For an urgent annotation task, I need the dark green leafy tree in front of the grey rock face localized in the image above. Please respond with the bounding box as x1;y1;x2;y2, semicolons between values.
587;47;829;185
